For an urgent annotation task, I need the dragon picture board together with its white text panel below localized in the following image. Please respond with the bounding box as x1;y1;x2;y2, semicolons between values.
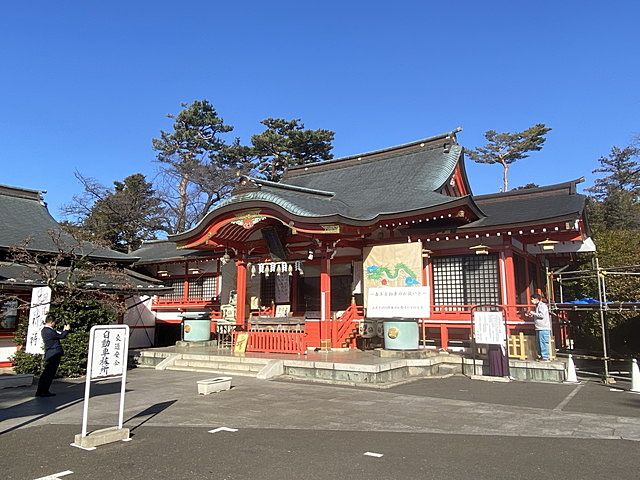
363;242;429;318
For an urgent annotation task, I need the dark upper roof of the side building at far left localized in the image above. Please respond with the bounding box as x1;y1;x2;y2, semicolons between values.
0;185;136;263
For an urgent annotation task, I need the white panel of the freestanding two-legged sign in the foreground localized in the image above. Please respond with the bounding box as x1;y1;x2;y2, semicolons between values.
87;325;129;380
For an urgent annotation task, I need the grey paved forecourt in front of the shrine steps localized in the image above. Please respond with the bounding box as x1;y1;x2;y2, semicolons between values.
0;369;640;480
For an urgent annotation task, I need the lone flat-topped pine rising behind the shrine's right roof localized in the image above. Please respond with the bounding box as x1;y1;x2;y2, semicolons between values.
467;123;551;192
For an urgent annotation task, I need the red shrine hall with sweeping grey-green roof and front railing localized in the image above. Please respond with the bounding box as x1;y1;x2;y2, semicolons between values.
134;130;595;353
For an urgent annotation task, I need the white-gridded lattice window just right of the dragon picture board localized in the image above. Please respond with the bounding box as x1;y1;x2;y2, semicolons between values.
433;254;500;305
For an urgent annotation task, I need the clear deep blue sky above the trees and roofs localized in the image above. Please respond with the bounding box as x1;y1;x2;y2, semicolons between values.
0;0;640;216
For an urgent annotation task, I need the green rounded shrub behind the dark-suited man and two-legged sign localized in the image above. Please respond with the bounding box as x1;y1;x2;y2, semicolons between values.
13;300;116;377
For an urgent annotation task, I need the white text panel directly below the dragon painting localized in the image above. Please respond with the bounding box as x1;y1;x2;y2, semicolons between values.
367;287;431;318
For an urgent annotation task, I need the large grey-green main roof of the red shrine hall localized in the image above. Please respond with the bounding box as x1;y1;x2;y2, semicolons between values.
216;132;466;221
